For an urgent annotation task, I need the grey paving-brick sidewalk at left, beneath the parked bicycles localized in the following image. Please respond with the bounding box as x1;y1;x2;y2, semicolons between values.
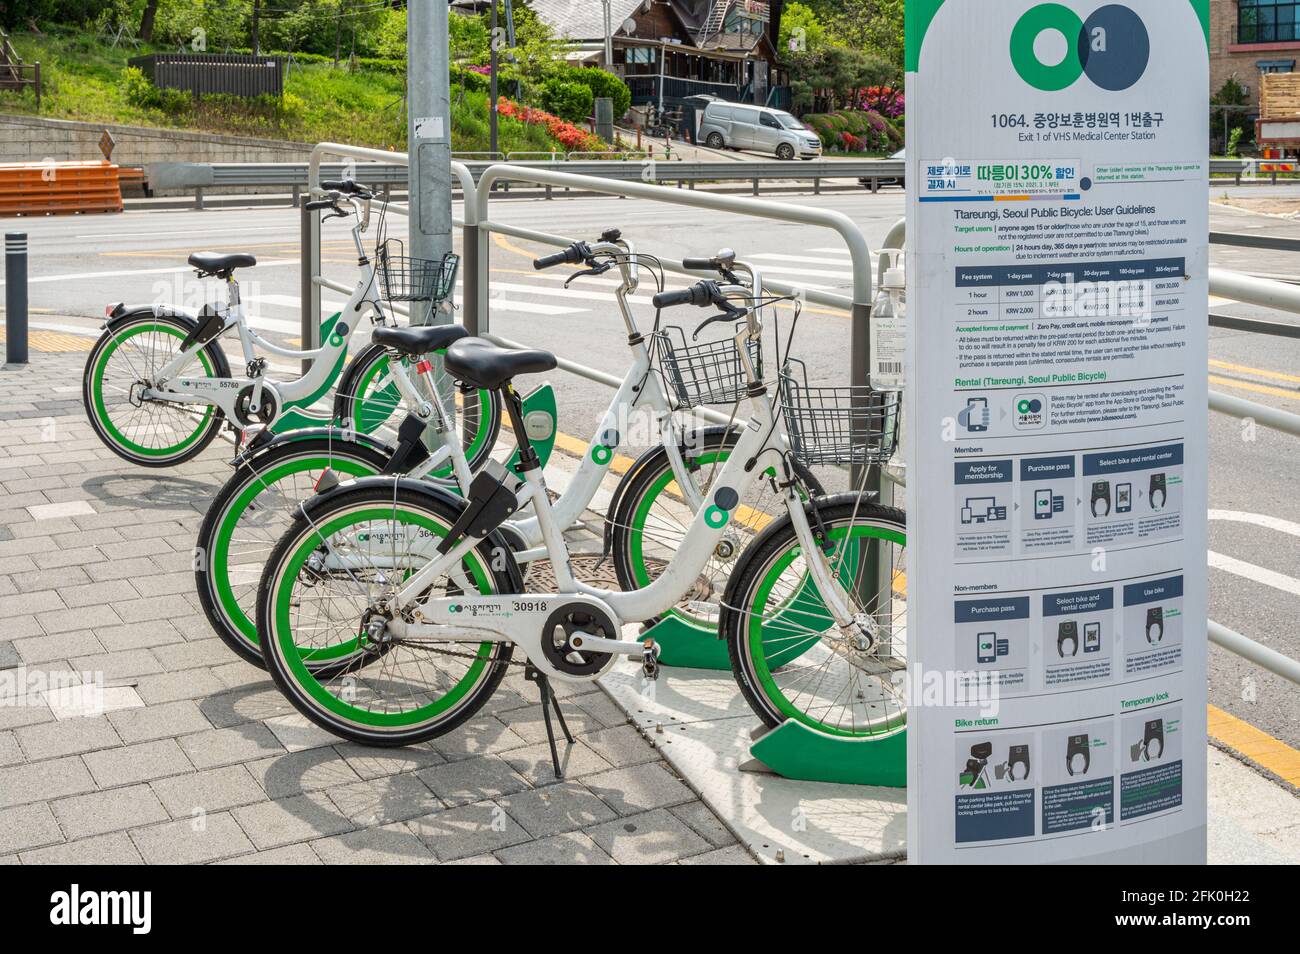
0;342;753;864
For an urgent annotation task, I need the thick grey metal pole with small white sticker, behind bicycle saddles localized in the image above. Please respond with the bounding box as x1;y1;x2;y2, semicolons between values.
407;1;451;324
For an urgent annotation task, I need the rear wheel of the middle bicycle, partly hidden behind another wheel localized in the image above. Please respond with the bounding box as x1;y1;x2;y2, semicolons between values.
194;437;389;665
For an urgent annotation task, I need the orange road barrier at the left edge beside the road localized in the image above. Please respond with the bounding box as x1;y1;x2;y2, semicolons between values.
0;161;122;216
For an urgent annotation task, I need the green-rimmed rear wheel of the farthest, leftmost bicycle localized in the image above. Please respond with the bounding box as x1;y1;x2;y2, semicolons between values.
82;312;224;467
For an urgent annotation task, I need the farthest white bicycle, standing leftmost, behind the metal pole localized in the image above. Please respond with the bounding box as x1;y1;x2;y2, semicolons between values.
82;179;470;467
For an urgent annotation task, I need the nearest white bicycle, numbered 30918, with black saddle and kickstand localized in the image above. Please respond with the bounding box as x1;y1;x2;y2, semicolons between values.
250;265;906;774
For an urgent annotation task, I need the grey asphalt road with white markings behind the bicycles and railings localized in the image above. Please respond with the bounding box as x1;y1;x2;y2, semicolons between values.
7;187;1300;746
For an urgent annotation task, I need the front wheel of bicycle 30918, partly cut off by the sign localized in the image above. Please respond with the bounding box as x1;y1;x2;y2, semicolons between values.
720;494;907;737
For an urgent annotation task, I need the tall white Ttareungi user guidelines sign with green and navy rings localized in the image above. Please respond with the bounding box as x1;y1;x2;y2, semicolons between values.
906;0;1210;864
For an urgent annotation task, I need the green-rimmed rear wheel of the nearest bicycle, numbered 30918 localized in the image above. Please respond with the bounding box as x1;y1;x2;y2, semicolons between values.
257;478;519;746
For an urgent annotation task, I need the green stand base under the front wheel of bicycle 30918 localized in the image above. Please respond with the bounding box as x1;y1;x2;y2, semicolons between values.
741;719;907;789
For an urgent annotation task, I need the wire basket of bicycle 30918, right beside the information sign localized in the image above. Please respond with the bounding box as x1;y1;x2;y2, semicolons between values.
780;359;902;465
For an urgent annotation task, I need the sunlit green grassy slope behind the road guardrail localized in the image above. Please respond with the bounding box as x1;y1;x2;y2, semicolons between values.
0;34;563;152
